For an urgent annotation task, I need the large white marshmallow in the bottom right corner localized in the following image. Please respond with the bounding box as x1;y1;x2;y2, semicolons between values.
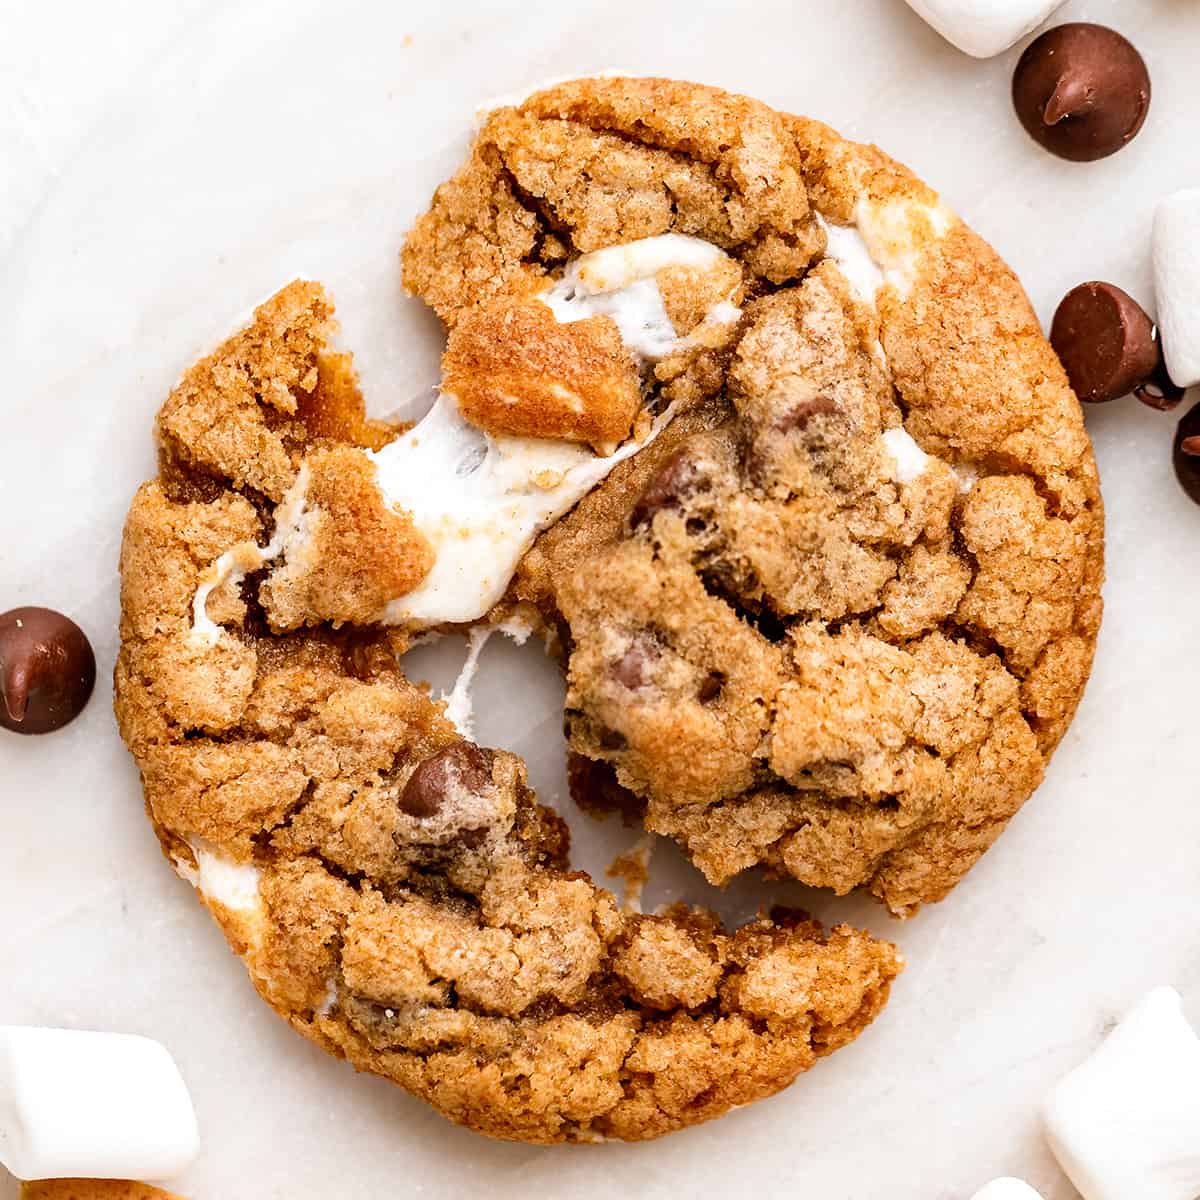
1043;988;1200;1200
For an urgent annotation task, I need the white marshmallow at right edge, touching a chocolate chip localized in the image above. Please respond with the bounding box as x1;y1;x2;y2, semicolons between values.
1154;188;1200;388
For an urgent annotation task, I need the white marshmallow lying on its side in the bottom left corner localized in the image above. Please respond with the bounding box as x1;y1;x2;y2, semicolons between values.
0;1025;200;1180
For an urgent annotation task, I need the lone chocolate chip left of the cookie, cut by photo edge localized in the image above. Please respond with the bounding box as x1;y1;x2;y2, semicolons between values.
0;608;96;733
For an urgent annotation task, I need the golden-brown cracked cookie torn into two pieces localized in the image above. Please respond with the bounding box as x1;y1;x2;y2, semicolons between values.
116;72;1103;1141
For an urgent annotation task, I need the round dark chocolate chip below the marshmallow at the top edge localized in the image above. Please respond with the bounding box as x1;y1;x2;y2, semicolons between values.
1013;22;1150;162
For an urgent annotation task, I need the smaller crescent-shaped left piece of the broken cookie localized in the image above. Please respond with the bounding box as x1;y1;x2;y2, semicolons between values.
116;267;901;1142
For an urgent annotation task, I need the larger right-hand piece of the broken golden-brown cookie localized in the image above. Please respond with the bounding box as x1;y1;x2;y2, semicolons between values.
404;79;1103;916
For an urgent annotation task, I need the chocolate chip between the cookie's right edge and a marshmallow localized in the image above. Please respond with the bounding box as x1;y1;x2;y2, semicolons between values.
1050;282;1160;404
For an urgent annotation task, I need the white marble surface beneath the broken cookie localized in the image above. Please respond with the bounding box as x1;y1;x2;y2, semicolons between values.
0;0;1200;1200
